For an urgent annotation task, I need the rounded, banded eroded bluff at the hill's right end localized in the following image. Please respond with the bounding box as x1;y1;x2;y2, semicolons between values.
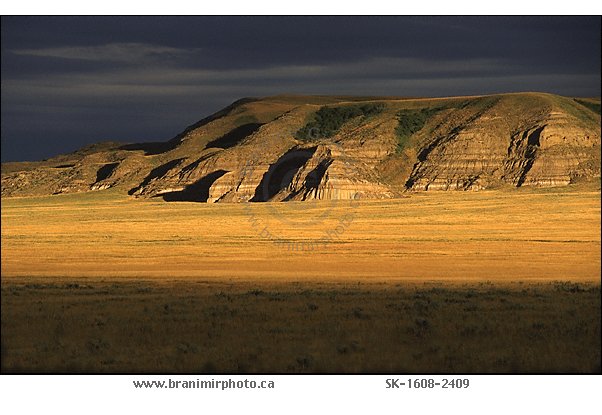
398;94;600;190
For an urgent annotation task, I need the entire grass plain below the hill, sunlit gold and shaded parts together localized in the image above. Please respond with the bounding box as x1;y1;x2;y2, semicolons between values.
1;183;600;373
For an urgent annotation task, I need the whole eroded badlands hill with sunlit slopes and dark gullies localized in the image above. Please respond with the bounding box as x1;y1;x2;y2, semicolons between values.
2;93;600;202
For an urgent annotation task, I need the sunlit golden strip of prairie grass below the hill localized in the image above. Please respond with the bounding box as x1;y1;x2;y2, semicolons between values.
1;188;600;282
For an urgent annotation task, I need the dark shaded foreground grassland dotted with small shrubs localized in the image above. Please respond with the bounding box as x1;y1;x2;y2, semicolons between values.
2;278;600;373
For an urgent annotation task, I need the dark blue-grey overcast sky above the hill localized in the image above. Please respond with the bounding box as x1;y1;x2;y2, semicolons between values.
1;17;601;161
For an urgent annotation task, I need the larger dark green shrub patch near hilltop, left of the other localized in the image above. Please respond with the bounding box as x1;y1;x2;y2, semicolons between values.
295;104;385;141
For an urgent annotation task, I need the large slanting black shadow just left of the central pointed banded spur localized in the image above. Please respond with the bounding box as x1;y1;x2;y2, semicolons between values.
250;147;317;202
